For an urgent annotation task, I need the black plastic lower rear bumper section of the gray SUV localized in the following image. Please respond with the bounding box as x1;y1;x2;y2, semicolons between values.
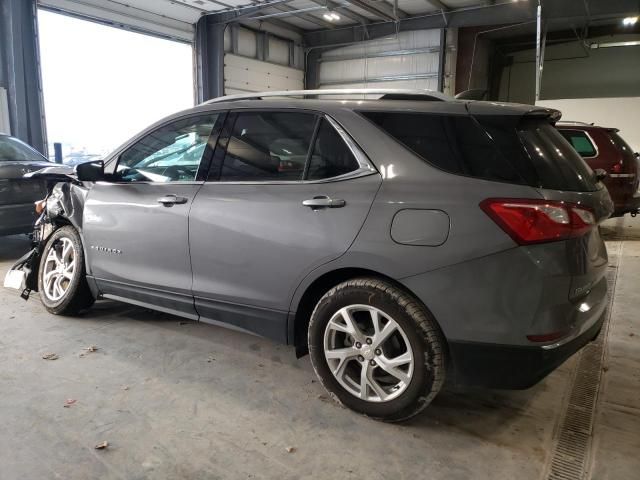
449;311;606;389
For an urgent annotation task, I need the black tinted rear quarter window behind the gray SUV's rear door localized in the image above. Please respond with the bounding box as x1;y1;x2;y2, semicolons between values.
361;112;527;184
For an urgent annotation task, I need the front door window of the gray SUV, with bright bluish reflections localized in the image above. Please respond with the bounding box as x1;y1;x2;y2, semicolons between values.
115;114;218;183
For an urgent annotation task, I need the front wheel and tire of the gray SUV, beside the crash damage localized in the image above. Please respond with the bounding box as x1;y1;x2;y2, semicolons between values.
38;226;95;315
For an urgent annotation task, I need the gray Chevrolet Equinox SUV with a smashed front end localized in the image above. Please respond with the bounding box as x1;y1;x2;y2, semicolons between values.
6;91;613;421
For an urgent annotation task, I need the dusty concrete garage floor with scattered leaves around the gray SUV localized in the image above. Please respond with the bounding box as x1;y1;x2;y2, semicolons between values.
0;219;640;480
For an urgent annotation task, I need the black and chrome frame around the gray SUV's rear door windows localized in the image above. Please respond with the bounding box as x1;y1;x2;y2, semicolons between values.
205;107;378;185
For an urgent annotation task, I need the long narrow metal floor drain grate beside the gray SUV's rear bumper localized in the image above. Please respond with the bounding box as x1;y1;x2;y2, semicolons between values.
547;242;622;480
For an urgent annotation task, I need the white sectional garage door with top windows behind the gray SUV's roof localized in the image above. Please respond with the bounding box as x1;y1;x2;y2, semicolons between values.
224;27;304;95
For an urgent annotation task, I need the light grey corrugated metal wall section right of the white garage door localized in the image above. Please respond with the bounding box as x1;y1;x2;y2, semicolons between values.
320;30;440;90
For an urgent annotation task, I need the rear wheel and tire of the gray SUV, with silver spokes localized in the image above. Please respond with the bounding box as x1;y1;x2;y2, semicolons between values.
308;278;446;422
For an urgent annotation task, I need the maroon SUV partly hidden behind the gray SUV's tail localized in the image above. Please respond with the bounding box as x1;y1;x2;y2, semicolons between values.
556;122;640;217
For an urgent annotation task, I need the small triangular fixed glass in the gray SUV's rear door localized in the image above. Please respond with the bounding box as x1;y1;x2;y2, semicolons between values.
306;120;359;180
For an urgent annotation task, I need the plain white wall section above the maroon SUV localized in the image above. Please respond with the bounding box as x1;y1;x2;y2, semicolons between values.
538;97;640;152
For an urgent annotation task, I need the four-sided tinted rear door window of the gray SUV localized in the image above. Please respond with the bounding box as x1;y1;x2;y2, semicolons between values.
220;112;317;182
